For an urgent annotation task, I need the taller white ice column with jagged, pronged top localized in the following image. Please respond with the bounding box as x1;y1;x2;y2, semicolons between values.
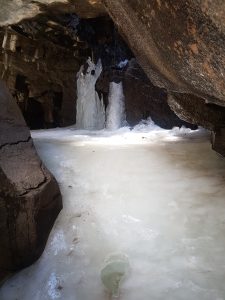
76;58;105;130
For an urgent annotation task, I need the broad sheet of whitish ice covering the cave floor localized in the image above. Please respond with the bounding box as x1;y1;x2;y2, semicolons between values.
0;126;225;300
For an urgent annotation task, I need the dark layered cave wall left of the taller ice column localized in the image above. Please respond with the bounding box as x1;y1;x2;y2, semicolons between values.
0;20;85;129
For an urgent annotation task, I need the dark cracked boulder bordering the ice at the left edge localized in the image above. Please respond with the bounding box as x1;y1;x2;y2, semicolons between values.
0;82;62;282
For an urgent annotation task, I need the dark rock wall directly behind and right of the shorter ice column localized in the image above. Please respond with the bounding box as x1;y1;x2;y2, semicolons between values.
96;59;197;129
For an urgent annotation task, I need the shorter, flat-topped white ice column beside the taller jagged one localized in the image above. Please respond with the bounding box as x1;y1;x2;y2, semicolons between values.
106;82;126;130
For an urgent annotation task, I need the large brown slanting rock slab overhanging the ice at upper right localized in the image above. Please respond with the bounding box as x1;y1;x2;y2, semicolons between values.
103;0;225;105
